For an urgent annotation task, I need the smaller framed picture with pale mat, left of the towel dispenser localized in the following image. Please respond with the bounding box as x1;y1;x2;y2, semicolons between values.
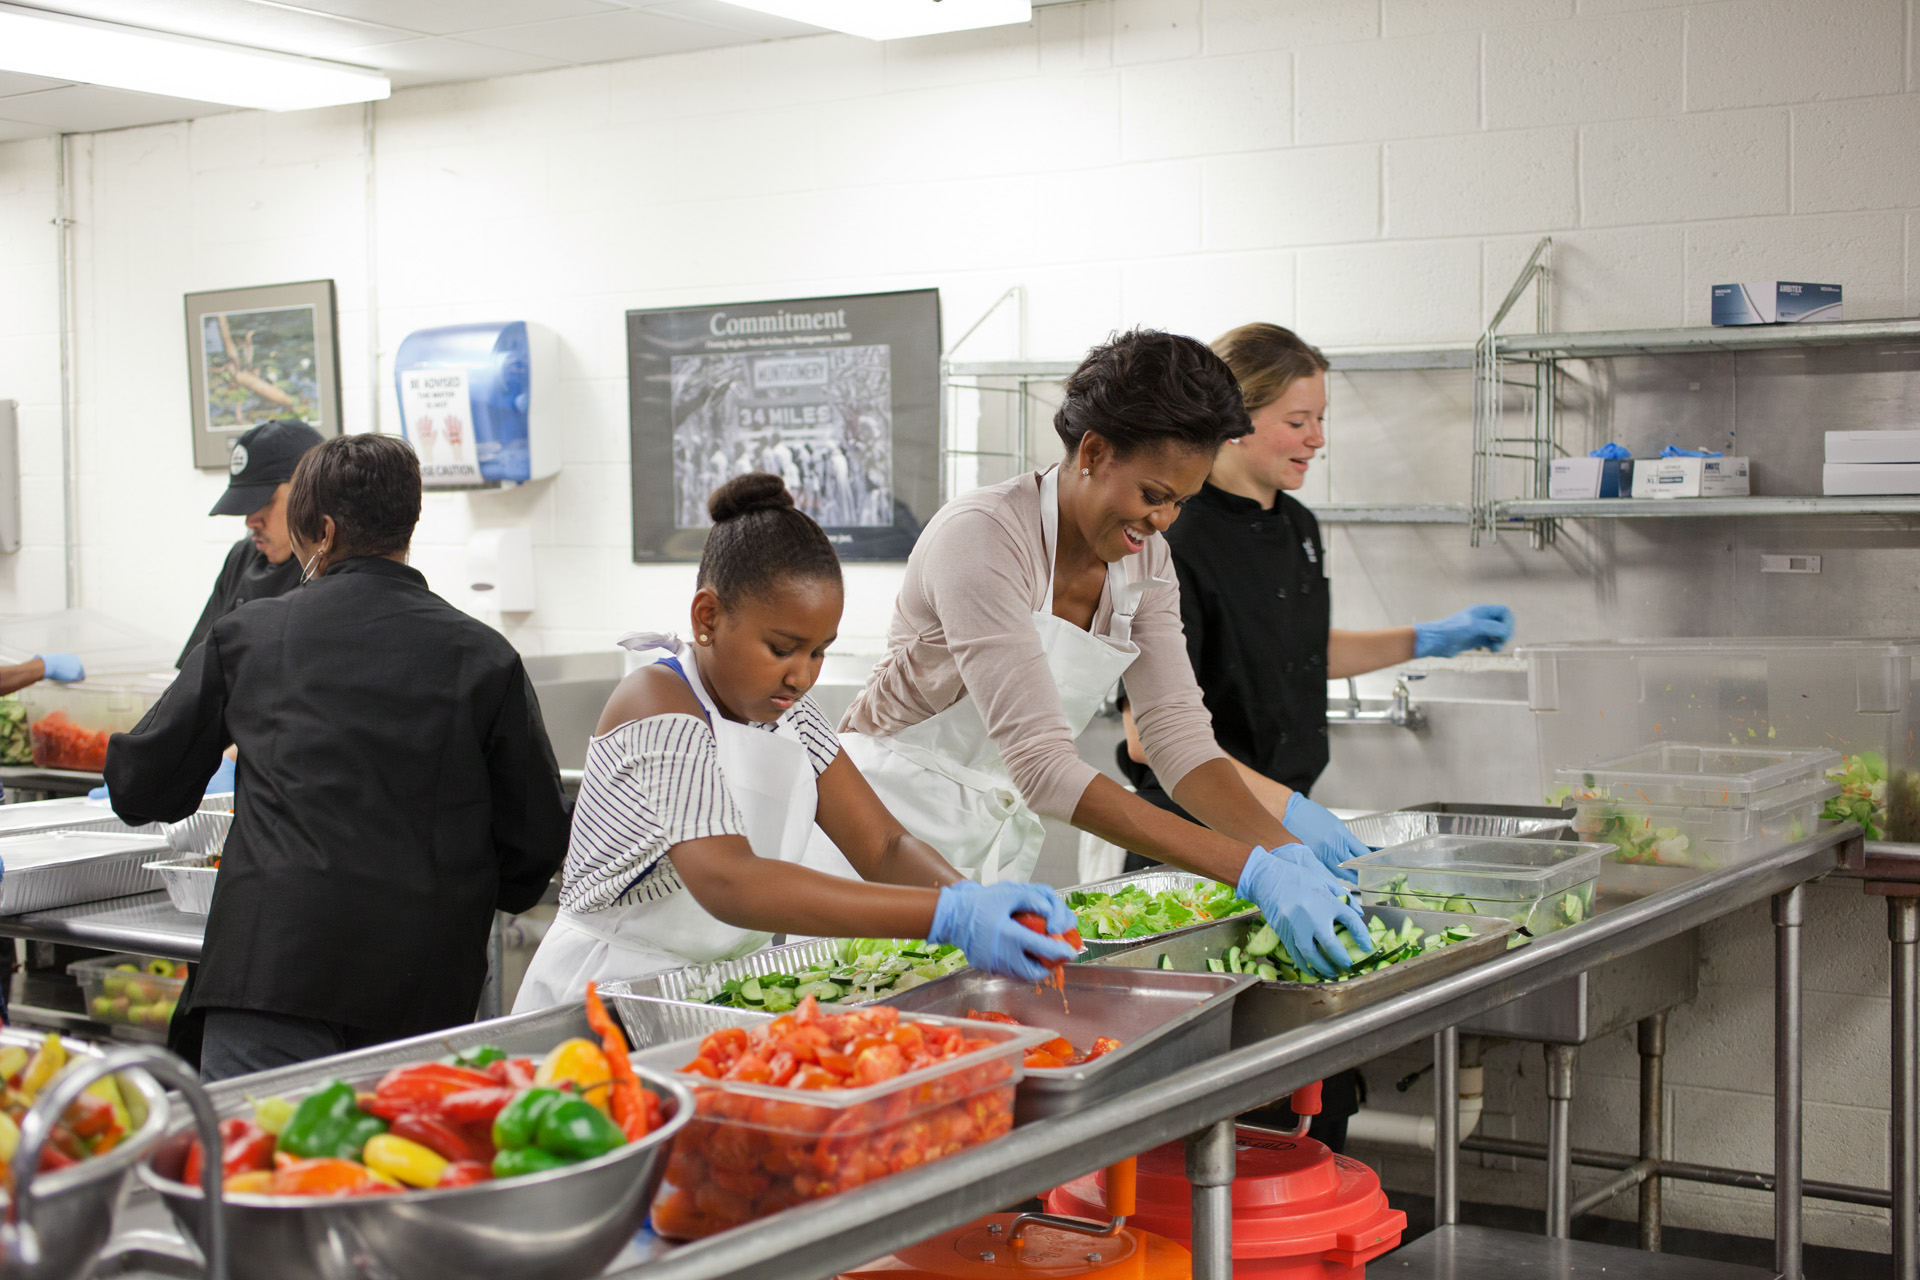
186;280;340;470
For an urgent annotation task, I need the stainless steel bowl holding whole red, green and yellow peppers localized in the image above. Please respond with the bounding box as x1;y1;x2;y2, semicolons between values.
140;1069;693;1280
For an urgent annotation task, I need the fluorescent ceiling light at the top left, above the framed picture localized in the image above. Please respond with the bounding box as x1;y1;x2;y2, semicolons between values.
0;4;394;111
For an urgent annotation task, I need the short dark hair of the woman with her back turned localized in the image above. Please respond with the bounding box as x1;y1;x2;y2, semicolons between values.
286;434;420;560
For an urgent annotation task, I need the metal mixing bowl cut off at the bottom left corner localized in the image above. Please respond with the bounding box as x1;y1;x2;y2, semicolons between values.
0;1027;167;1280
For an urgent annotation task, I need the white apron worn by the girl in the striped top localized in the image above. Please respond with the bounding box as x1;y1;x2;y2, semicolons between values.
513;631;818;1013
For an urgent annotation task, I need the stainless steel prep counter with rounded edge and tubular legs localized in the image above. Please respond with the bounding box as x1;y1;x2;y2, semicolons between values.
93;825;1862;1280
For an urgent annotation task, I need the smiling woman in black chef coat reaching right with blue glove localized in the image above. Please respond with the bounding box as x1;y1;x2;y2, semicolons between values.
1119;324;1513;1150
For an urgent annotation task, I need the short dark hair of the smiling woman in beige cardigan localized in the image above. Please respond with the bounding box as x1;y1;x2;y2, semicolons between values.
1054;328;1254;457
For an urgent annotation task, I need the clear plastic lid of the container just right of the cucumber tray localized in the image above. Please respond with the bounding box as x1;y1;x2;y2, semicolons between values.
1340;835;1613;902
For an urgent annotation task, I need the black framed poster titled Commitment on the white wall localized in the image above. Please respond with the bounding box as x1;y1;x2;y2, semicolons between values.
626;290;941;564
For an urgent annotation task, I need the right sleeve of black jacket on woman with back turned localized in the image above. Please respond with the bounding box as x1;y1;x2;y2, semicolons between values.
486;668;566;912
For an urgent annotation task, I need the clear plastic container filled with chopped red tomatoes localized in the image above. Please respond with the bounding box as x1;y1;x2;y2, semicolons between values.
634;1015;1054;1240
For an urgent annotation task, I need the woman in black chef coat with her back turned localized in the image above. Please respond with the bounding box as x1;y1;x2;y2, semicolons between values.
106;436;566;1080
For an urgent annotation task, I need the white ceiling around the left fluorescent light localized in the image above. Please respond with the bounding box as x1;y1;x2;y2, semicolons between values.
0;0;818;142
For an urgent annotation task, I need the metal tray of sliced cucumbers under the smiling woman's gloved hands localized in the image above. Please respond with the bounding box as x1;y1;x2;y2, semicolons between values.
1094;906;1513;1048
